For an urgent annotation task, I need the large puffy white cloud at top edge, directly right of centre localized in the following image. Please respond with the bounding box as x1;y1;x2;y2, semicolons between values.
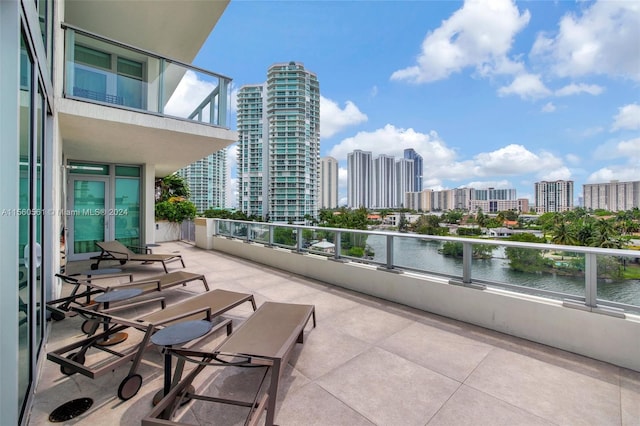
391;0;530;83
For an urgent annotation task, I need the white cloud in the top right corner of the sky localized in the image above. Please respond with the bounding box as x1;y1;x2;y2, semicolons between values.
531;1;640;80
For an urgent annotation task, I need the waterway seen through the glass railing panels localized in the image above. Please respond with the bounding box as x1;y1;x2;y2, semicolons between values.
367;235;640;306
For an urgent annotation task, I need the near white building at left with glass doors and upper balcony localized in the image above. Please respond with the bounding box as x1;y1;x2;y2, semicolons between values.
0;0;237;425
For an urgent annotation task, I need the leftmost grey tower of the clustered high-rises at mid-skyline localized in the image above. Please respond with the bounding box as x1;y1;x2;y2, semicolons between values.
347;149;373;209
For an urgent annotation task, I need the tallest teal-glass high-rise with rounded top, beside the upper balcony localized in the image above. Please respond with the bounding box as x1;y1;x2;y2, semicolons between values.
238;61;320;223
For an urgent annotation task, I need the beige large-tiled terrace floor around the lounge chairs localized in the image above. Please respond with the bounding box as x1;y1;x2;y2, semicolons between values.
29;241;640;425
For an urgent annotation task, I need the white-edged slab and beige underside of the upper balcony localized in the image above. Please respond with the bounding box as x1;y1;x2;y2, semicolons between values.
58;99;237;177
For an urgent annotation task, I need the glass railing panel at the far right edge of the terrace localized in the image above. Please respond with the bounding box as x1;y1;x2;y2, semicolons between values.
597;254;640;310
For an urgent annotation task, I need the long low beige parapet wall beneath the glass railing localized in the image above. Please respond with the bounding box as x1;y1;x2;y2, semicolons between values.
204;230;640;371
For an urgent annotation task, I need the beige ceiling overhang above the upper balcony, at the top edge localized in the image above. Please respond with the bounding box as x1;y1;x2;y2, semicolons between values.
64;0;229;63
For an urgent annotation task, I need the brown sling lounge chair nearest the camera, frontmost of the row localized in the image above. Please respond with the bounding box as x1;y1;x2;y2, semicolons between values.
142;302;316;426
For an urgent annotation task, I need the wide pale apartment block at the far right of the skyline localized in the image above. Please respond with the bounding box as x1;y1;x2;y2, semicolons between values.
582;180;640;212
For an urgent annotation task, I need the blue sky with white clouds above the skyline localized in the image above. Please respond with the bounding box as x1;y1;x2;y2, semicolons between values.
194;0;640;207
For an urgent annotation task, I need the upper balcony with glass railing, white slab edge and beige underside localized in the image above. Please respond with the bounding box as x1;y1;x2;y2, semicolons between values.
58;24;236;176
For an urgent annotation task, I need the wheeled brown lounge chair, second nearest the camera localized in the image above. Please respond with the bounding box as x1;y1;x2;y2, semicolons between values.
47;289;256;400
